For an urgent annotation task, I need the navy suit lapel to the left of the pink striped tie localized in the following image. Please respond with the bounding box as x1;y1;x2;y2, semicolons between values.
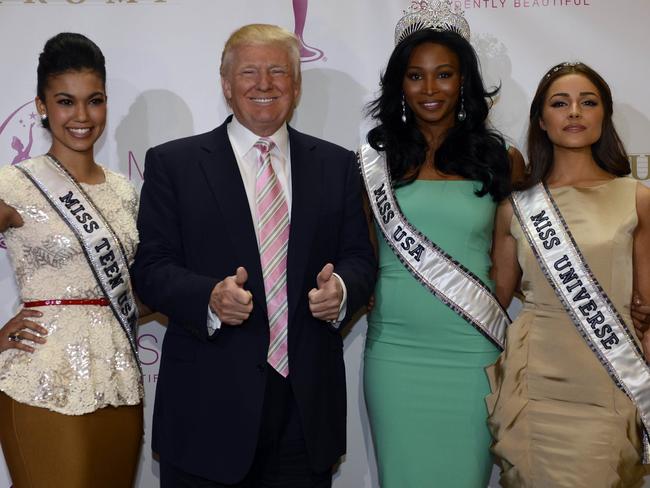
200;118;266;315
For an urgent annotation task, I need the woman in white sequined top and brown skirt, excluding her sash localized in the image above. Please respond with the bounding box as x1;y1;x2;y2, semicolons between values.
0;33;143;488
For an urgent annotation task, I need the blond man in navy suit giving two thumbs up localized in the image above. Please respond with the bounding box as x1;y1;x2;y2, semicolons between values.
133;24;376;488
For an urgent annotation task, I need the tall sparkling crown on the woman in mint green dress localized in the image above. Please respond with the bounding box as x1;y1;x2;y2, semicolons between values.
395;0;470;45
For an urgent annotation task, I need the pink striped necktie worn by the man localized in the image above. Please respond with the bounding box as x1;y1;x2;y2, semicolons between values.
255;137;289;378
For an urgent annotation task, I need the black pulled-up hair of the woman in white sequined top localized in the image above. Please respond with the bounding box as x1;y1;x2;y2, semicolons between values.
36;32;106;130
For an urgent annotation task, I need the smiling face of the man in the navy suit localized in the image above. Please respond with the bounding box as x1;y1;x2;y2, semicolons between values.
221;44;300;136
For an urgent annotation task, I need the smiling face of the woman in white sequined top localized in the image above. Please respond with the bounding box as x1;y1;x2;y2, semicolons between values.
36;70;106;160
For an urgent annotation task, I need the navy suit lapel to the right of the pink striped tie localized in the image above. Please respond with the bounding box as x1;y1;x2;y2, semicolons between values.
287;127;323;324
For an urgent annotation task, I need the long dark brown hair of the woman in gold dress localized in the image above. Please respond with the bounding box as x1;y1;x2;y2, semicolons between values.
517;63;630;190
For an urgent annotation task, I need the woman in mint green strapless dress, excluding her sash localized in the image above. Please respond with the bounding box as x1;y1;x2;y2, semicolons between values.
362;2;523;488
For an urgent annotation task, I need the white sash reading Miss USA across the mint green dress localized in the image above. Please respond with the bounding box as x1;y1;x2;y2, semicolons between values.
359;144;510;349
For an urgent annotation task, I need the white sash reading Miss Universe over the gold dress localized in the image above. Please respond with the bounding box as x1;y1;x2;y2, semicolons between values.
510;183;650;464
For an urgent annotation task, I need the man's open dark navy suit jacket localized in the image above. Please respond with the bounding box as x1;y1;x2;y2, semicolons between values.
133;119;376;483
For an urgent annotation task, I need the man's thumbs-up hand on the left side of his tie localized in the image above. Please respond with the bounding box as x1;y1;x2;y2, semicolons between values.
210;266;253;325
